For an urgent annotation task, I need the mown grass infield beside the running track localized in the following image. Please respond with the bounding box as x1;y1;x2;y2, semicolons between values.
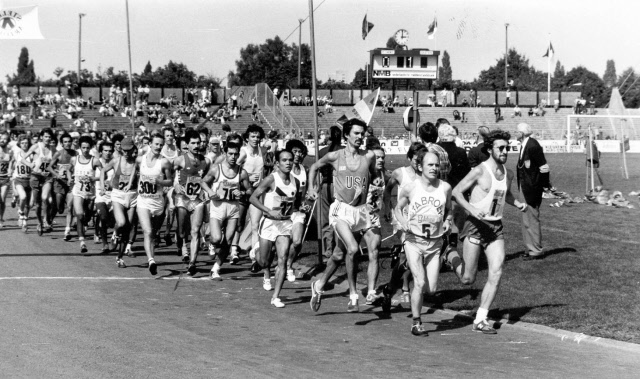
301;154;640;343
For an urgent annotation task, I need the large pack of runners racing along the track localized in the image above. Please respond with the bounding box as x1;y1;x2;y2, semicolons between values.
0;119;526;336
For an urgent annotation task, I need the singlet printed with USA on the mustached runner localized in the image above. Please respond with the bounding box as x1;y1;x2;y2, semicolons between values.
333;149;369;207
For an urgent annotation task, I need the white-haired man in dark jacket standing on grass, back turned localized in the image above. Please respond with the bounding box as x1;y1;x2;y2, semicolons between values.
516;122;550;260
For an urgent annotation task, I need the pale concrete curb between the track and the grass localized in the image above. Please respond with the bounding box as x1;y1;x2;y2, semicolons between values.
301;265;640;354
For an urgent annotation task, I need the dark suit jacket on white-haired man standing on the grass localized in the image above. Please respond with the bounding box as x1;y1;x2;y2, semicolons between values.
517;137;550;207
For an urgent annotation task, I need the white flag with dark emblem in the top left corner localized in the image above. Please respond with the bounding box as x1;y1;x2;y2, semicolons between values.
0;5;44;39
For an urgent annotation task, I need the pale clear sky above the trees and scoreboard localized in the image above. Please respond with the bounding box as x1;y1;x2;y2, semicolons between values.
0;0;640;86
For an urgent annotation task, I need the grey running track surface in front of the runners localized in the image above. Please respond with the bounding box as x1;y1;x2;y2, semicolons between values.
0;217;640;378
